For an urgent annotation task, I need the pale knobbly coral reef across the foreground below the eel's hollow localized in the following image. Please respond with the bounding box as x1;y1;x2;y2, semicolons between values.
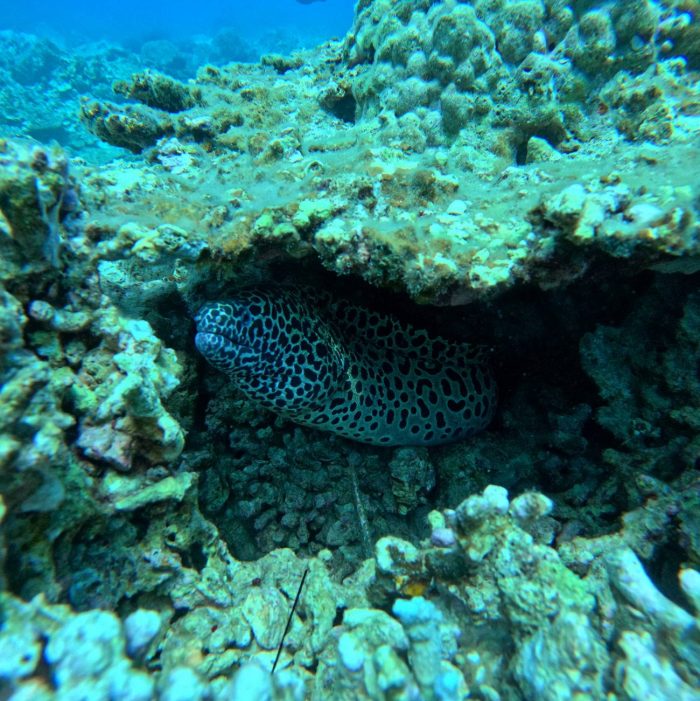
0;486;700;699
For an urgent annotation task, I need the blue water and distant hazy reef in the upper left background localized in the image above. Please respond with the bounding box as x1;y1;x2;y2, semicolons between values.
0;0;353;154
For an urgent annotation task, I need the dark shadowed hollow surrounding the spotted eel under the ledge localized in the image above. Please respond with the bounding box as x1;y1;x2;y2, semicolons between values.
188;259;696;559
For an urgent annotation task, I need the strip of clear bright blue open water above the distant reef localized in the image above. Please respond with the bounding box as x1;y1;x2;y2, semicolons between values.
0;0;354;50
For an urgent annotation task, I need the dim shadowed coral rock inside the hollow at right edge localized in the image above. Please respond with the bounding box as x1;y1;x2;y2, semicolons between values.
581;274;700;486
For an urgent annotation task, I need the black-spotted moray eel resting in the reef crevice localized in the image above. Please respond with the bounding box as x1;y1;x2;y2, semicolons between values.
195;289;496;446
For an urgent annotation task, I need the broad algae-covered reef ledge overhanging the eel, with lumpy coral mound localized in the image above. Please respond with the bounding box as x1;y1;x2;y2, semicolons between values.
52;0;698;305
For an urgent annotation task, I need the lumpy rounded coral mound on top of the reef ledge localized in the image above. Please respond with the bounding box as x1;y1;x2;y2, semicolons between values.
345;0;684;152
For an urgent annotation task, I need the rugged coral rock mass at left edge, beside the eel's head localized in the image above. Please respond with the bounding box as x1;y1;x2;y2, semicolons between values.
0;138;192;608
